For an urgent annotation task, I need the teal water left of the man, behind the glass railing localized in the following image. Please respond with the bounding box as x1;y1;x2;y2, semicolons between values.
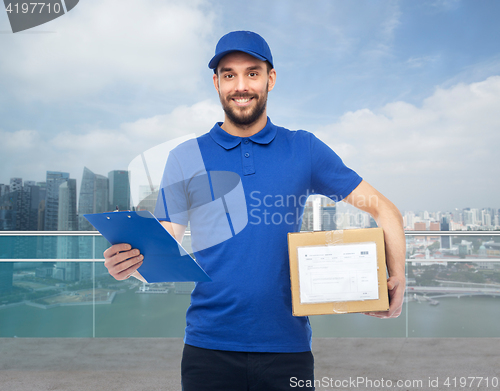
0;289;190;338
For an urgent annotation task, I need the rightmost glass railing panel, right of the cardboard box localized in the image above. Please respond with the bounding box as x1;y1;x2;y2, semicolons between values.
407;234;500;337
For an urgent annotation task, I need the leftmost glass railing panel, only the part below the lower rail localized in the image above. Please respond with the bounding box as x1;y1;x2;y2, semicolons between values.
0;262;94;338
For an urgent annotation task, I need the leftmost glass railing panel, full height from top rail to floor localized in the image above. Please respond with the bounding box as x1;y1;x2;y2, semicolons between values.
0;233;109;337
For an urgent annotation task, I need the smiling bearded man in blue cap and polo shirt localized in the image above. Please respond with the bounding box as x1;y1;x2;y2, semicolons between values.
104;31;405;391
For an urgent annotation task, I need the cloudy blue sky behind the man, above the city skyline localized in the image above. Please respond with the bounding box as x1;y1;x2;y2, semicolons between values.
0;0;500;211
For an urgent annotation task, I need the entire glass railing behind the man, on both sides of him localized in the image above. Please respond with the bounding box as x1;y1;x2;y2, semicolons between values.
0;233;500;337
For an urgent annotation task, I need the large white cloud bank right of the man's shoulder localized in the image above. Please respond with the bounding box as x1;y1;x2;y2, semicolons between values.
315;76;500;209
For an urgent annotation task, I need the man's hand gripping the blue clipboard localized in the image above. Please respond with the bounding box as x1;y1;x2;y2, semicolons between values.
104;243;144;280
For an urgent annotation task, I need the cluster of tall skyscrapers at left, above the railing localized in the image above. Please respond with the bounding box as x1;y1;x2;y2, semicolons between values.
0;167;131;233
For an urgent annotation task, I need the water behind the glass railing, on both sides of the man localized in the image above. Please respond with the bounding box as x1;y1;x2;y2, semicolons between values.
0;288;500;338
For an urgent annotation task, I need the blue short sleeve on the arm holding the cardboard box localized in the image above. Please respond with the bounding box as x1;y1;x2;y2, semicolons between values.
310;133;362;201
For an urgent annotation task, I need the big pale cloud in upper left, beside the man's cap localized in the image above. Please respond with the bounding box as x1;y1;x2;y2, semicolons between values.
0;0;215;101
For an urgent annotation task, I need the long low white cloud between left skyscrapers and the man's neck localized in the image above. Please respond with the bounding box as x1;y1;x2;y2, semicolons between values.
0;100;222;183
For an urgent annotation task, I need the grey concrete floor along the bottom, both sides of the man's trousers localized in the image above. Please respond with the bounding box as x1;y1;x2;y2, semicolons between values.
0;338;500;391
